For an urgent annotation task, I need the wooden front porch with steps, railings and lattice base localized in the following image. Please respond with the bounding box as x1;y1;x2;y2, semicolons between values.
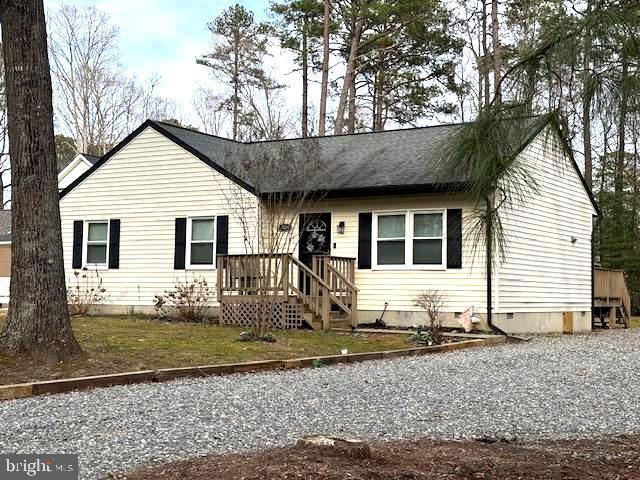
217;253;358;330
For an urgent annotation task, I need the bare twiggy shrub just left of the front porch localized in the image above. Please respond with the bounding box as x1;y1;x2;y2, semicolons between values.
154;277;216;323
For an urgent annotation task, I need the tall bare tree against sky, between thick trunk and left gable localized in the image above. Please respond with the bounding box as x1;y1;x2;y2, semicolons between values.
49;5;177;155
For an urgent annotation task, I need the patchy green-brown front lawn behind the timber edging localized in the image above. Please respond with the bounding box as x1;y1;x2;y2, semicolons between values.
0;316;413;384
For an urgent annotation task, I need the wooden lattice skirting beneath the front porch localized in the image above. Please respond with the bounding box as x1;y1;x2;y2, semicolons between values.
220;297;304;329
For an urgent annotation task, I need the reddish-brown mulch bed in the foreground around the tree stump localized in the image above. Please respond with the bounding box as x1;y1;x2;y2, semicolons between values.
124;437;640;480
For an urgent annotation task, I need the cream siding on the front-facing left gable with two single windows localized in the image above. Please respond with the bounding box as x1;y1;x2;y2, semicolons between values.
60;128;257;306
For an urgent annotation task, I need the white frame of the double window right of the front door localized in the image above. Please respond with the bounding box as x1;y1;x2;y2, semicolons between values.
371;208;447;270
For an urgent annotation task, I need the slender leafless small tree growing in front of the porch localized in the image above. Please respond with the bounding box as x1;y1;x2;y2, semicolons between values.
220;139;325;339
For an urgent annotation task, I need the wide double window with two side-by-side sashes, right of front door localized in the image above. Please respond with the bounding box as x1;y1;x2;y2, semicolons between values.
373;210;446;270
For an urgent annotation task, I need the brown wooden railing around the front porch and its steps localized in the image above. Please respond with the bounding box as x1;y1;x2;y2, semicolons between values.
217;253;358;329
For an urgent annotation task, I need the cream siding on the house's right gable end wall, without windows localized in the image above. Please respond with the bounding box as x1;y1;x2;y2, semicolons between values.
495;126;596;321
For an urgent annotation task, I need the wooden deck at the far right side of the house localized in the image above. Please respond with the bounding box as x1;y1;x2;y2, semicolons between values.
593;268;631;328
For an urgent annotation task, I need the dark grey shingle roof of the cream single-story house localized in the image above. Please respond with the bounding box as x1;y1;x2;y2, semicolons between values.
155;122;478;191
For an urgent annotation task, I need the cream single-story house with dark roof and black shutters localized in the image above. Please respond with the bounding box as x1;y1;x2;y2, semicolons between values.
60;116;598;333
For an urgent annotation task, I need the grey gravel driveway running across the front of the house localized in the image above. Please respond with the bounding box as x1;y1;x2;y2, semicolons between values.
0;329;640;478
